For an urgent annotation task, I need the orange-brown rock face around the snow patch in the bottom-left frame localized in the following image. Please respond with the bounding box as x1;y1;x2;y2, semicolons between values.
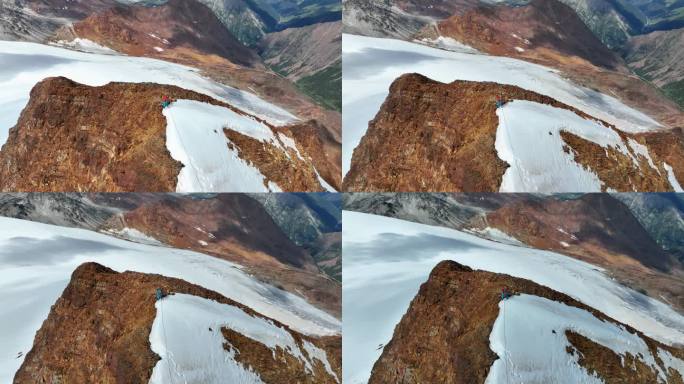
14;263;341;384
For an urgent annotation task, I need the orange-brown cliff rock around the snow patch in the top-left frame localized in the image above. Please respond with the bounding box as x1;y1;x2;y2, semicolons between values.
0;78;331;192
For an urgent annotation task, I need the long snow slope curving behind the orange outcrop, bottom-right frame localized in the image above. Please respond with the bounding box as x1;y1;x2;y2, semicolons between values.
342;211;684;384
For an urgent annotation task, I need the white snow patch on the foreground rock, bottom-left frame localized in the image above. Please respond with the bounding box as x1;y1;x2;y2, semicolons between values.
150;294;334;384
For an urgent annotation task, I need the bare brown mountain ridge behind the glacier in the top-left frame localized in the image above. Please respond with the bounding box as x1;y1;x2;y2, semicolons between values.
51;0;342;168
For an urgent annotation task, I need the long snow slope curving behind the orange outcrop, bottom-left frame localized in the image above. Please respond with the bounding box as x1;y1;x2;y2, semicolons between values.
0;218;340;382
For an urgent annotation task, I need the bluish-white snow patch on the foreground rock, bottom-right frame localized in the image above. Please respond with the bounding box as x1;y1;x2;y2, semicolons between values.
485;294;672;384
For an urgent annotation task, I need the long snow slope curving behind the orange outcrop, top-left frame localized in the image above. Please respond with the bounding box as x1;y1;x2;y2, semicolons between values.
0;41;296;145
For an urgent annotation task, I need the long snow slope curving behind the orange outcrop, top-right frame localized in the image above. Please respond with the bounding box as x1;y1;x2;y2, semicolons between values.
342;34;659;174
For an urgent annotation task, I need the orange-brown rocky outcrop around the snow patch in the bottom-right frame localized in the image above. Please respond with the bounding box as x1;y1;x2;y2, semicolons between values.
369;261;684;384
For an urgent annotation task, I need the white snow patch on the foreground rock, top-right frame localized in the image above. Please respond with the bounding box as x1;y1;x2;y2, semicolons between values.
495;100;631;193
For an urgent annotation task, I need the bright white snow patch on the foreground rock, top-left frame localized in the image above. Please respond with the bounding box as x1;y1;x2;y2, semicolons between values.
162;100;281;192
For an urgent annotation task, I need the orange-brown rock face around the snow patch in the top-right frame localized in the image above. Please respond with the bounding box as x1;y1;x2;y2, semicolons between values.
343;74;684;192
